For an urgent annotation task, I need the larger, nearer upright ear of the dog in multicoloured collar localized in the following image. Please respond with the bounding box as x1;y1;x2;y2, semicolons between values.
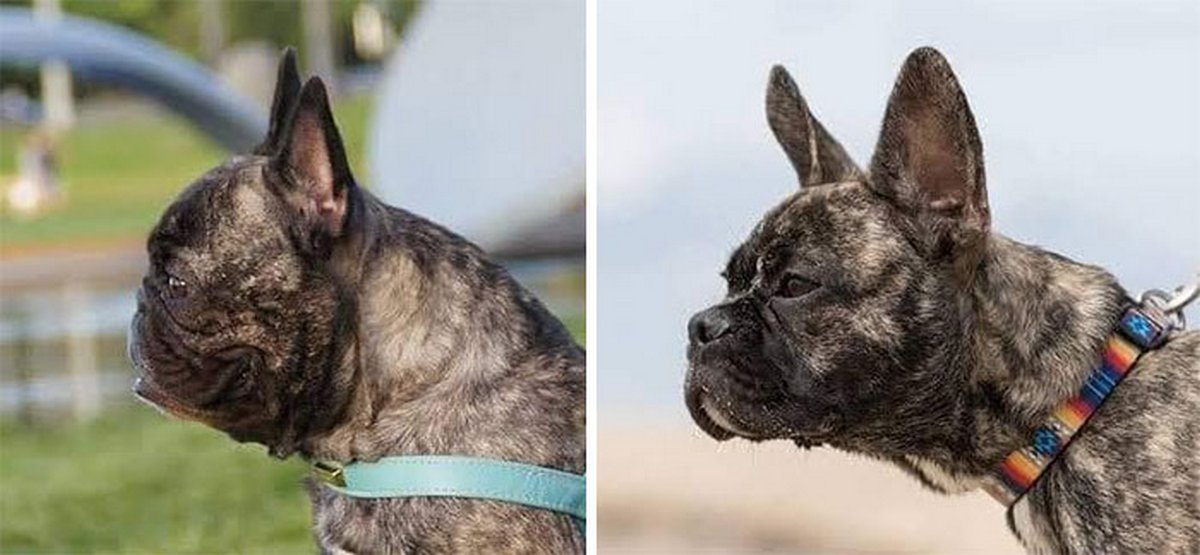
870;47;991;247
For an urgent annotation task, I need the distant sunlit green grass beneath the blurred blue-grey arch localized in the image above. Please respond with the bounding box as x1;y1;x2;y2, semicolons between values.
0;96;371;250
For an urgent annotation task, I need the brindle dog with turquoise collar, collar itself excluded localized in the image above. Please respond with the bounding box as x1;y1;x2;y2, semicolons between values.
130;50;584;554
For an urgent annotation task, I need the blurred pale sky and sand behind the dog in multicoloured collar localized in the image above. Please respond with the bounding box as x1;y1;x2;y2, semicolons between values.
596;0;1200;554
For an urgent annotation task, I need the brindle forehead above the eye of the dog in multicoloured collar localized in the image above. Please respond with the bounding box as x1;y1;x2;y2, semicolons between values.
725;181;902;294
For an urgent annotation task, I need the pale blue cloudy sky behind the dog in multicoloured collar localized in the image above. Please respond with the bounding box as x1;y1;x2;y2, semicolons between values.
596;0;1200;419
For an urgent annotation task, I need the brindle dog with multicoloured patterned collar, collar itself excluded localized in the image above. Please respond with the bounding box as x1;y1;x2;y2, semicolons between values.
685;48;1200;554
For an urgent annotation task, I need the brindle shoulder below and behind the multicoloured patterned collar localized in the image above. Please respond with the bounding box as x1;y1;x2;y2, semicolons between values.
1012;330;1200;553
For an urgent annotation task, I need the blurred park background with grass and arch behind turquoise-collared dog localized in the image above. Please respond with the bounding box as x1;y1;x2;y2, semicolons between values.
0;0;584;553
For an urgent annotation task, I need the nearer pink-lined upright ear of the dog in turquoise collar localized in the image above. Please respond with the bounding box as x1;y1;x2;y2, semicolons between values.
271;77;355;237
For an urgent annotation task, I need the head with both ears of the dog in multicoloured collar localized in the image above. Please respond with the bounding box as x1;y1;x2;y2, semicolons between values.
685;48;989;454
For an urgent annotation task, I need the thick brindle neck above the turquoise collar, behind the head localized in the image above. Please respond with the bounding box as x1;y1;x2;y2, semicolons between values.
297;197;583;466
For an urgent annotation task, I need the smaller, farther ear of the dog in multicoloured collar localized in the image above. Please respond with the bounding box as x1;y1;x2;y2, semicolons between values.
767;66;863;187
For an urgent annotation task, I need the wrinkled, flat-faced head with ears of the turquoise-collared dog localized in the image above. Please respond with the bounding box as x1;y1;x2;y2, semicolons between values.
130;49;355;455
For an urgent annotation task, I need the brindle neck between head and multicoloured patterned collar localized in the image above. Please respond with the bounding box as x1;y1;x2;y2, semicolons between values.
902;235;1126;491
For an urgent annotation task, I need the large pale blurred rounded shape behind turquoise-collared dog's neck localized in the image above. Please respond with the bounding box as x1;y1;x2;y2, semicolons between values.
367;0;586;249
